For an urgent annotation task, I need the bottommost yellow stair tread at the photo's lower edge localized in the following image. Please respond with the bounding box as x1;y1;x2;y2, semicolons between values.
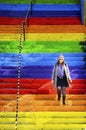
0;124;86;130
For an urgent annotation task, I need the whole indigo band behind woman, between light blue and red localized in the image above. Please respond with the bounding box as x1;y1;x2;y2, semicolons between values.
0;66;86;79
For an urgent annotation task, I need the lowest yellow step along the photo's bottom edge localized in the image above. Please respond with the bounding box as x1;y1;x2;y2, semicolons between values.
0;122;86;130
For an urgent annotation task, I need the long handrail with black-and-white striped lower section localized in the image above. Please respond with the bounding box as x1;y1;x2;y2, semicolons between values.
15;0;33;130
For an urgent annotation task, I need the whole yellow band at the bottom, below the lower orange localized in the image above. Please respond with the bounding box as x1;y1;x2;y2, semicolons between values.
0;112;86;130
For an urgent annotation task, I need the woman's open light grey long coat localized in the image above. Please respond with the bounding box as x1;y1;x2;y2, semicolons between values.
52;63;71;88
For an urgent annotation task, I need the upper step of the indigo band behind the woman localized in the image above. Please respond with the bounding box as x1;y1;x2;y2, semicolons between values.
0;66;86;75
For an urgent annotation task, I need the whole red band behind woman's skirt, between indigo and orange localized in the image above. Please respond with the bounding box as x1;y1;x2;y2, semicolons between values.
0;78;86;94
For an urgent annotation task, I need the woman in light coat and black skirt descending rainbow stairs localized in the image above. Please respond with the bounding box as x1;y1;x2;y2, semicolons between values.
52;54;72;105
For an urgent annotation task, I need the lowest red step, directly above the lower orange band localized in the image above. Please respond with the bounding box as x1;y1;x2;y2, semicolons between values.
0;89;86;95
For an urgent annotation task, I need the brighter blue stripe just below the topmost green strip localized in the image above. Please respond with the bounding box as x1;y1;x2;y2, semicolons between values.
0;4;80;11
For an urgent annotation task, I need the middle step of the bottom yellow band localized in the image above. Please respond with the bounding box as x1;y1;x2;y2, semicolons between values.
0;117;86;124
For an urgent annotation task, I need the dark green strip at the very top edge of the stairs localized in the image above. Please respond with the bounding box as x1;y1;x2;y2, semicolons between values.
0;0;80;4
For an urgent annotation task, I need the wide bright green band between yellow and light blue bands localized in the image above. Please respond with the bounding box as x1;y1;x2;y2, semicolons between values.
0;41;83;53
